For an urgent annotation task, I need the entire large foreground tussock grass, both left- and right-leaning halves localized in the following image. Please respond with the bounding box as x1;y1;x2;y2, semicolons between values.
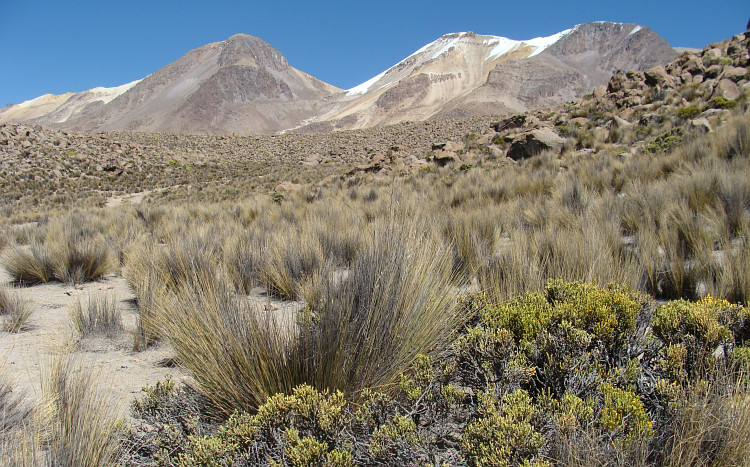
158;219;459;413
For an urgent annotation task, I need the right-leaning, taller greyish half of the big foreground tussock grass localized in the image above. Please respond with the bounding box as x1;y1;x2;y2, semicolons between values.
293;222;461;394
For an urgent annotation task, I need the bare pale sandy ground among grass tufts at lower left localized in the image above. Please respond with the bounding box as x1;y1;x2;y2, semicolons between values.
0;267;187;416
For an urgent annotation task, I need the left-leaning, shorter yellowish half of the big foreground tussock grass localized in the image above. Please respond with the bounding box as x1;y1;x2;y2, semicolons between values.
155;266;294;413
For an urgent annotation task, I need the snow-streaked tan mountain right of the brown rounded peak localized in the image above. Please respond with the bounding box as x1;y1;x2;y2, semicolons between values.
301;22;677;131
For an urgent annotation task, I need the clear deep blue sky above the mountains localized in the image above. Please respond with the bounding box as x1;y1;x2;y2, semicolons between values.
0;0;750;106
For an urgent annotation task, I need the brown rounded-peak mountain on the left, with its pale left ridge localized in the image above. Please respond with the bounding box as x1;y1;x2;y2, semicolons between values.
0;34;340;134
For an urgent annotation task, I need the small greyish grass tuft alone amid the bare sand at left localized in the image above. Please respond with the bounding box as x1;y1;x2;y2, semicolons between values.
68;294;122;337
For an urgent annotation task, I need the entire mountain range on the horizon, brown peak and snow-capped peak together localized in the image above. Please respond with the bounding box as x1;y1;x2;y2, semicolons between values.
0;22;676;134
